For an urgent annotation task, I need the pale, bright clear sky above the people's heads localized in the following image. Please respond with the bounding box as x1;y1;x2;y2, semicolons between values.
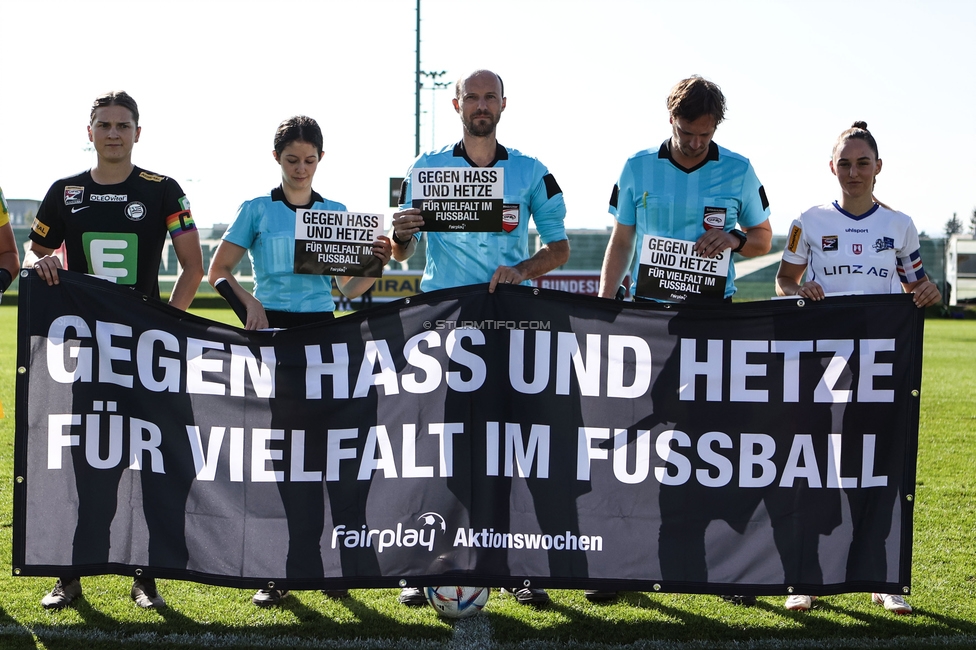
0;0;976;236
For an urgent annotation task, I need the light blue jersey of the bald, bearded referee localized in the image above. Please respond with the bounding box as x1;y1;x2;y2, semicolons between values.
400;142;566;291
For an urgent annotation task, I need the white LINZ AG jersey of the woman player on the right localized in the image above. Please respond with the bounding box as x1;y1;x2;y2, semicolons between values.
783;201;925;294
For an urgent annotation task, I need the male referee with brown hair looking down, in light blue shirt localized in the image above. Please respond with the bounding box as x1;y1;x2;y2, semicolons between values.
600;75;773;300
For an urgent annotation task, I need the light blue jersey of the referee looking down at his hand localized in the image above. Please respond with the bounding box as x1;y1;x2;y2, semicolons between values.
610;140;769;298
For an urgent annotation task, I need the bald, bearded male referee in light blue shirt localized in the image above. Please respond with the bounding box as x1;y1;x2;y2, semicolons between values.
391;70;572;606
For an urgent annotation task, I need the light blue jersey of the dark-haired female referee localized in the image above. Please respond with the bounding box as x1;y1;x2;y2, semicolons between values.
223;187;346;313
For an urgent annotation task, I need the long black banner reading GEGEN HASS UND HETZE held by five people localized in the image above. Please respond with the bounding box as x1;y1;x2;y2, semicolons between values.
13;272;922;595
